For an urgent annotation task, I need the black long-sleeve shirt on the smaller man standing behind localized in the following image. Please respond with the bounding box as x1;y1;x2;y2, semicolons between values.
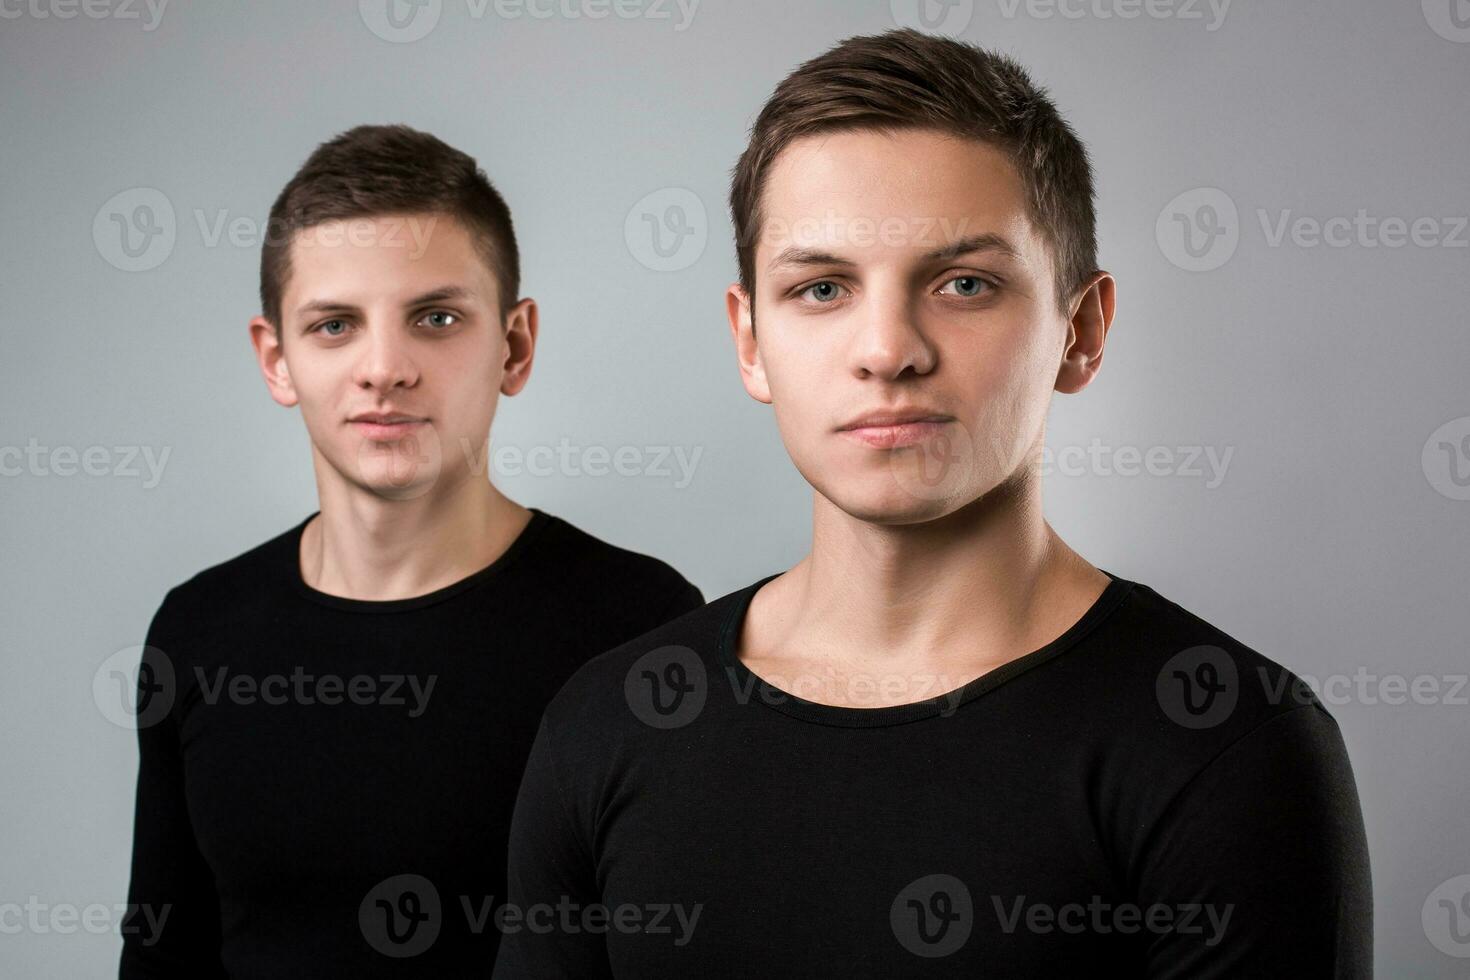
121;508;703;980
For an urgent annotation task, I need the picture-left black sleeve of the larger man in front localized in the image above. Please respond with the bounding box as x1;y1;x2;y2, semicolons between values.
494;717;612;980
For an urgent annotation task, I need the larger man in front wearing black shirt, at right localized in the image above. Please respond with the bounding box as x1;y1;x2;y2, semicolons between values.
495;31;1372;979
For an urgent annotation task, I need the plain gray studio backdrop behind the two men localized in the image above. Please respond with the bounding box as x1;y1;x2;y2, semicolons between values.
0;0;1470;980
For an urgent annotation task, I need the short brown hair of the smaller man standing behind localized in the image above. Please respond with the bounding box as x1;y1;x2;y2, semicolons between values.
260;125;520;332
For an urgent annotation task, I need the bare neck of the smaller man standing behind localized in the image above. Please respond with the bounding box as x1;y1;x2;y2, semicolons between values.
300;449;531;601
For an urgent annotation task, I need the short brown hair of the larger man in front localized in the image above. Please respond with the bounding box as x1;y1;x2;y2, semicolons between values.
731;28;1097;311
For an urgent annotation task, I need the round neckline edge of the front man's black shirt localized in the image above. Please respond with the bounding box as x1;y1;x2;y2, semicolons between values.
717;569;1136;729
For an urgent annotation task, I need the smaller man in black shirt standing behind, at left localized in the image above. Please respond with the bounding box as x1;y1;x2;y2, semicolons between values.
121;126;703;980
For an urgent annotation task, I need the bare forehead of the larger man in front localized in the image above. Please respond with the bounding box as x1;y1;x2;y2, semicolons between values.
756;129;1044;267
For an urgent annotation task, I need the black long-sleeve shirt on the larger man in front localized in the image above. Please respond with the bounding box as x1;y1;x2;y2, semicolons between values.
495;576;1372;980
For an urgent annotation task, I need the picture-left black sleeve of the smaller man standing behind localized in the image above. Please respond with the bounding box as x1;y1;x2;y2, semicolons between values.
118;591;225;980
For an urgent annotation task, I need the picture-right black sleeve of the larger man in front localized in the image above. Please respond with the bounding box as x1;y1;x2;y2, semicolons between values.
1136;704;1373;980
